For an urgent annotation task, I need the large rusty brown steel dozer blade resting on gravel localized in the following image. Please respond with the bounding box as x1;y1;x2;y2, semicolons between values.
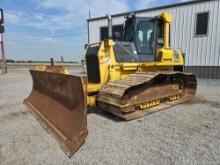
24;70;88;157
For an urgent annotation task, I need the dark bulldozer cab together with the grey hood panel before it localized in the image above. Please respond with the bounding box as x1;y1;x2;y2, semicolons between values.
114;15;164;62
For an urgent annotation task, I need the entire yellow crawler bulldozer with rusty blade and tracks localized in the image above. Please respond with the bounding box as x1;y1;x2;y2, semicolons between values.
24;13;197;156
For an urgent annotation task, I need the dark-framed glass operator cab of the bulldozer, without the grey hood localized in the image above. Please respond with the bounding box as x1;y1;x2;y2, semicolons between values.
124;17;164;61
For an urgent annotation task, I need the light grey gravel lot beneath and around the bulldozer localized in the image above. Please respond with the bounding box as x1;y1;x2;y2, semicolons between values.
0;69;220;165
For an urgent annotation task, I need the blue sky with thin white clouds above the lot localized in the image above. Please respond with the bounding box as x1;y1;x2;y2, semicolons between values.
0;0;186;61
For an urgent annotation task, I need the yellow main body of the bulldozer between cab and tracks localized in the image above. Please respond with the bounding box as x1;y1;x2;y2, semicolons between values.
87;43;184;93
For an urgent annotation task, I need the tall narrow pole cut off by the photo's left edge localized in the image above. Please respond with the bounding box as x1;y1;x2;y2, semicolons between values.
0;9;7;74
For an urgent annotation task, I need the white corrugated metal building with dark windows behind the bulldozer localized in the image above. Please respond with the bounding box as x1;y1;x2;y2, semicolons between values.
88;0;220;79
